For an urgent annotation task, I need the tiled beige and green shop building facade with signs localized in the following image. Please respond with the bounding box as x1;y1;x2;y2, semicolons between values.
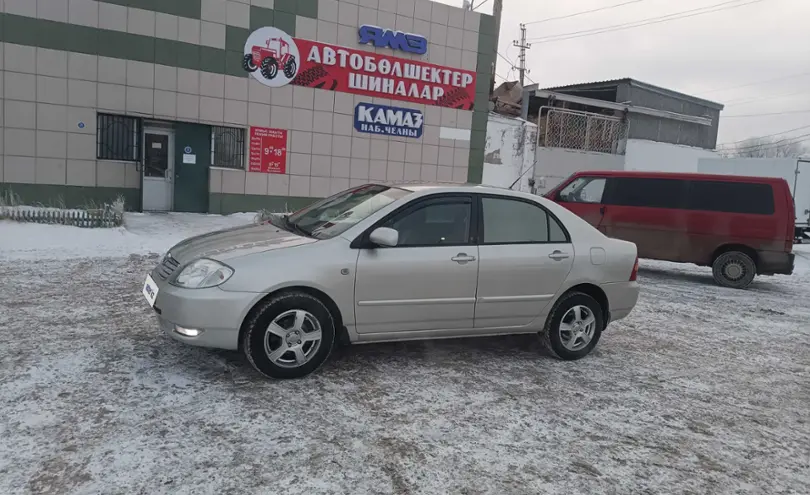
0;0;497;213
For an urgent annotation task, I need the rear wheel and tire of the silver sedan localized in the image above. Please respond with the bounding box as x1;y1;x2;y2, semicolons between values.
543;292;605;361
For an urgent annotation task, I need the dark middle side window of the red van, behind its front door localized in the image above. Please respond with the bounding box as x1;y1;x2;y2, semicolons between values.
604;177;688;209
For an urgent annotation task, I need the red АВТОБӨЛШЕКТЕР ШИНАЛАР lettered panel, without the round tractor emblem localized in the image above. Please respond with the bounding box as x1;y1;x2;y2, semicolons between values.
292;38;475;110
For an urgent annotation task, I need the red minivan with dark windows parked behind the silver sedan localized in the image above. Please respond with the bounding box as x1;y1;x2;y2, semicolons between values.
545;171;795;289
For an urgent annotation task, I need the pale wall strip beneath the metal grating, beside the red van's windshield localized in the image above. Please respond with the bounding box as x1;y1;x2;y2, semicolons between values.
534;148;625;194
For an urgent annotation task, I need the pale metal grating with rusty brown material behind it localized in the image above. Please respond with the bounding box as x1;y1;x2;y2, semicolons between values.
537;107;629;155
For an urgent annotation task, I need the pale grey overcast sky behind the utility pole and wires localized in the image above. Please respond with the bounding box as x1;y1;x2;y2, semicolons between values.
440;0;810;144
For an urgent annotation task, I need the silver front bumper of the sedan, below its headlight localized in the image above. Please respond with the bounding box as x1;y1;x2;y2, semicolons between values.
148;283;260;350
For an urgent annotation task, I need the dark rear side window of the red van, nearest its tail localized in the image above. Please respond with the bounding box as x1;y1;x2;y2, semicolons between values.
689;180;774;215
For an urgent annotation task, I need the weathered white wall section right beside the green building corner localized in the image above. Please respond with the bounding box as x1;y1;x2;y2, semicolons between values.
481;113;537;192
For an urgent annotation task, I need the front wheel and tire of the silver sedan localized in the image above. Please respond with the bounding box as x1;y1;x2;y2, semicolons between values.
242;291;335;378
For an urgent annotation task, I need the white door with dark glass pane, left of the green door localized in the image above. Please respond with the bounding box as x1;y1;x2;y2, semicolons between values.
143;128;174;211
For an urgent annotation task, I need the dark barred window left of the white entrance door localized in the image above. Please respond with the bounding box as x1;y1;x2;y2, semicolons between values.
96;113;142;162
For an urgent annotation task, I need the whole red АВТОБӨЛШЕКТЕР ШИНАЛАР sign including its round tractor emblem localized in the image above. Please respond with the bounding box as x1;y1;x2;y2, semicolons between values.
242;27;476;110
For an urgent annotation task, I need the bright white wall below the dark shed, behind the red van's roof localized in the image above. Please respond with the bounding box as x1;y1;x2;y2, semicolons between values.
624;139;719;172
